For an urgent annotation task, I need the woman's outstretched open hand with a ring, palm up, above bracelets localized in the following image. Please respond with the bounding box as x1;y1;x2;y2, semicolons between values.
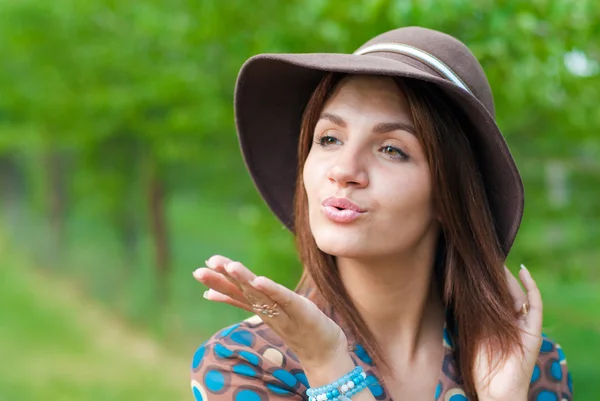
194;255;348;379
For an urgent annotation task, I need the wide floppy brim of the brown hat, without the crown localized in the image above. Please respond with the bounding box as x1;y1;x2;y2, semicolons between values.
234;53;524;255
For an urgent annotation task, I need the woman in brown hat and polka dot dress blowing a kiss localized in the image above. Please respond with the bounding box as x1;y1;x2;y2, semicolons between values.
192;27;572;401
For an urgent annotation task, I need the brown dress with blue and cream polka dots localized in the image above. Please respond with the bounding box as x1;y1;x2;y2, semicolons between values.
191;298;573;401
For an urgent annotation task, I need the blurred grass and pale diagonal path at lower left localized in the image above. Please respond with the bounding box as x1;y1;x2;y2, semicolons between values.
0;244;192;401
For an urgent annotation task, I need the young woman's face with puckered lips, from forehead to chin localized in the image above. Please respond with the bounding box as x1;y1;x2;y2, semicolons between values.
303;76;438;258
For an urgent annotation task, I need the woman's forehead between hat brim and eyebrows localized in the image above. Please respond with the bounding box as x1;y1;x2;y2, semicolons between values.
323;75;410;115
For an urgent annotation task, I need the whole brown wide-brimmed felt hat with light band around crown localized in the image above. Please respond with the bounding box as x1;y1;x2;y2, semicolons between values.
235;27;524;255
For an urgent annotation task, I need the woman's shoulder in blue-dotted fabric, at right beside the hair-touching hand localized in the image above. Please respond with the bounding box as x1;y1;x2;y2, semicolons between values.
529;334;573;401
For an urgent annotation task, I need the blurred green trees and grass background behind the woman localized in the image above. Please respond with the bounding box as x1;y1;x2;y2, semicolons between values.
0;0;600;401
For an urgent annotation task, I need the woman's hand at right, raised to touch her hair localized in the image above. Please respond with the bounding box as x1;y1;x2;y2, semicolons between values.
474;265;542;401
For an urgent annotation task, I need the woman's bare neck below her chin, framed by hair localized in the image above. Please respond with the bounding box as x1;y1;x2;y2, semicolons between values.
337;244;445;363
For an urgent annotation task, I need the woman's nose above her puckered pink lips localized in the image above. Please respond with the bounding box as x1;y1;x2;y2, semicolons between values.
327;147;369;188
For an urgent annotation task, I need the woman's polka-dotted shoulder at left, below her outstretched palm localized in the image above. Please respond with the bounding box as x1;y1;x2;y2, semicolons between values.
191;315;308;401
